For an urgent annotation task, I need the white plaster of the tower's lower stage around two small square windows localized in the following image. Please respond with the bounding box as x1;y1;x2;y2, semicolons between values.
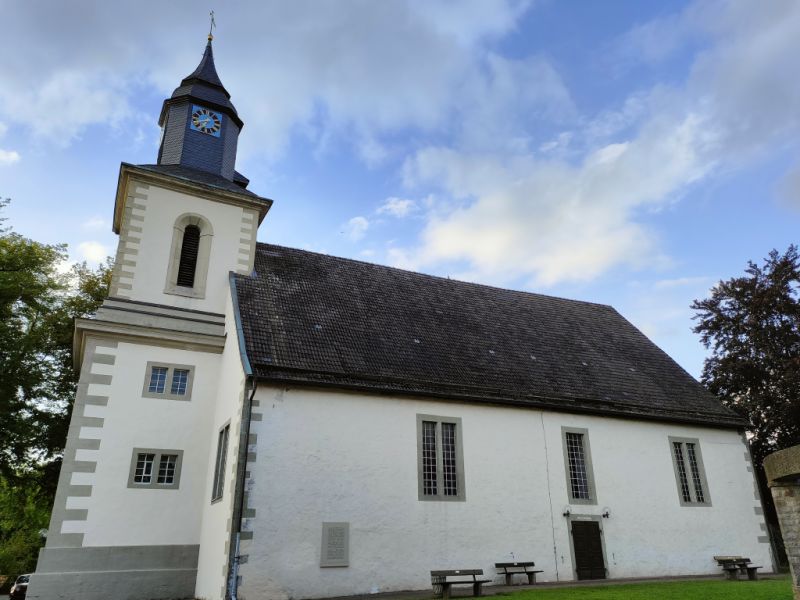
74;342;219;546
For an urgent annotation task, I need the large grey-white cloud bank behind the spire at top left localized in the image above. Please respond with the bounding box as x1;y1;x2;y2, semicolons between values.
0;0;536;156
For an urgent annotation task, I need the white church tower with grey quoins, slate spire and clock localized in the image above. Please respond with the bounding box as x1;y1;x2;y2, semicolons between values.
28;36;272;600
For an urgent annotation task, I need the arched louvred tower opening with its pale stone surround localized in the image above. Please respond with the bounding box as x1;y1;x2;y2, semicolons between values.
164;213;214;298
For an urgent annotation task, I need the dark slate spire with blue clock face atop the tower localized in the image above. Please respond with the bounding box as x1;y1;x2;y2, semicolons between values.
158;35;244;181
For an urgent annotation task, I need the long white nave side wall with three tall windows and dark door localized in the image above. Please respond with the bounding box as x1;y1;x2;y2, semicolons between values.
240;388;771;599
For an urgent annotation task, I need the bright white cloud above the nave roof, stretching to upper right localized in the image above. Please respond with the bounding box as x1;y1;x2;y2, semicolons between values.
396;0;800;286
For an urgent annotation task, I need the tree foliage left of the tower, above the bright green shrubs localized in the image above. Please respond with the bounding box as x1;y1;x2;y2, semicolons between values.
0;205;111;479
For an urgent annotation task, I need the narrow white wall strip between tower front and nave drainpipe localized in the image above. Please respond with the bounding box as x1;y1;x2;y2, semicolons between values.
195;294;245;600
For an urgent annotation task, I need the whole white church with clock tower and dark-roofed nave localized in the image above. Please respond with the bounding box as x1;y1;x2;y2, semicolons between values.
28;36;773;600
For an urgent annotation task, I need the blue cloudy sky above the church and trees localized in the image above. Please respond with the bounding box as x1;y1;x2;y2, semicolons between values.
0;0;800;377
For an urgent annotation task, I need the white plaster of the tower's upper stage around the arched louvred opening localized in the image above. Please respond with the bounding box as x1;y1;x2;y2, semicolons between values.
112;181;257;313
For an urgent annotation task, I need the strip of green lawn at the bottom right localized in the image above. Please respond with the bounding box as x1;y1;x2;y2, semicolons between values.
490;577;792;600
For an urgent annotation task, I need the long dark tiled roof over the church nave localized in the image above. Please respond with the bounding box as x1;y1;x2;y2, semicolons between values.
232;243;744;427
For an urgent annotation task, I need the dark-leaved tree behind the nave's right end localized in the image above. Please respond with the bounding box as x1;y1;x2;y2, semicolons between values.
692;245;800;464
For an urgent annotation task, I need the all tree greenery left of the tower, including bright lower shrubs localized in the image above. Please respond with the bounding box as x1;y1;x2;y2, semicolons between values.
0;199;111;574
